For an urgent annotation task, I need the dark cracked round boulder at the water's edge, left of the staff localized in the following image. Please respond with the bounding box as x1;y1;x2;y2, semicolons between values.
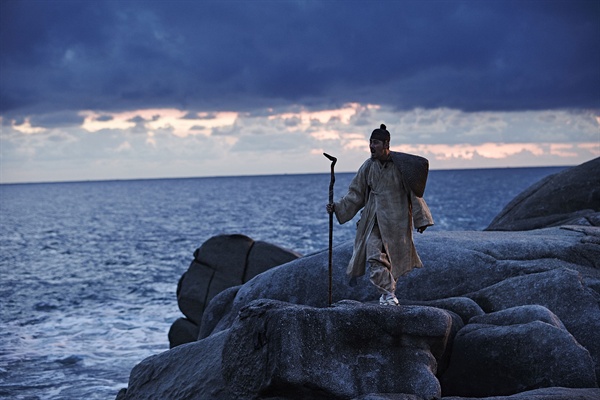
169;235;300;348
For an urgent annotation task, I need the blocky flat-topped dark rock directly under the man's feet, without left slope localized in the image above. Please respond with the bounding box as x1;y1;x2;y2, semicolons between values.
223;300;452;399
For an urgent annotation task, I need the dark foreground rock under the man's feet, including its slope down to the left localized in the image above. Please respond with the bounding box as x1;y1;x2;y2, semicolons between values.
118;300;452;400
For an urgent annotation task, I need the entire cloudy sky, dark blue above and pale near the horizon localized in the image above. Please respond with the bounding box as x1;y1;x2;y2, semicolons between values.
0;0;600;183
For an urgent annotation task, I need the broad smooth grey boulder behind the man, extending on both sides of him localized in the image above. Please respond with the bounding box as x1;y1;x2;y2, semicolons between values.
204;228;600;390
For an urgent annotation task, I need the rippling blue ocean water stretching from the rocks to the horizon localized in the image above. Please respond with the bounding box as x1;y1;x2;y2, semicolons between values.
0;167;564;400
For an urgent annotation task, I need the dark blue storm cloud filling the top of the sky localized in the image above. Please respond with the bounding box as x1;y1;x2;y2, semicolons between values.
0;0;600;116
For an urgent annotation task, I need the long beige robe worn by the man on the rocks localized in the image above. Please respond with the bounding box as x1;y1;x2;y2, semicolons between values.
335;159;433;279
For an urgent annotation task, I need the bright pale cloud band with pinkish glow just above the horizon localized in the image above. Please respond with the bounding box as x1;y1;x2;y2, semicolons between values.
0;103;600;183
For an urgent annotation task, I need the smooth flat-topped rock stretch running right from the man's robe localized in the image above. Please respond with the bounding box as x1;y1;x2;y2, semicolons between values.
394;228;600;300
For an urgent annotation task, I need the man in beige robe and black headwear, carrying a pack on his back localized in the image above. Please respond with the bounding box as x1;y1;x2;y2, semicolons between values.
327;124;433;305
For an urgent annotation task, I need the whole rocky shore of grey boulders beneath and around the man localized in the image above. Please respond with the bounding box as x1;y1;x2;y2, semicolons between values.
117;159;600;400
